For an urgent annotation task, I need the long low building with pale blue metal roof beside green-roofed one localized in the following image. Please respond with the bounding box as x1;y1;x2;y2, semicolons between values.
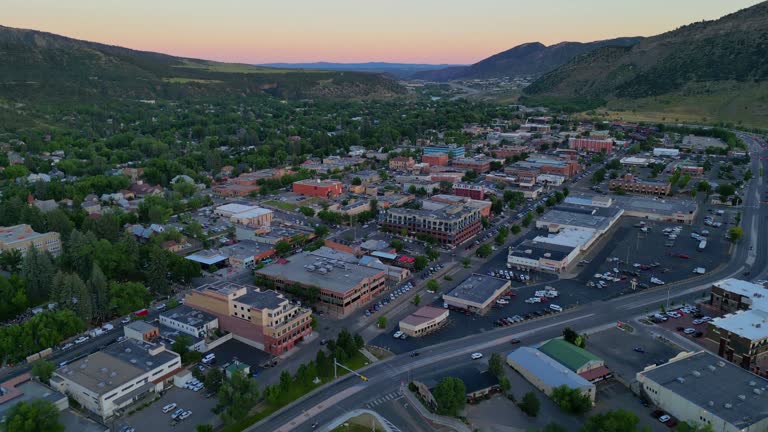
507;347;597;403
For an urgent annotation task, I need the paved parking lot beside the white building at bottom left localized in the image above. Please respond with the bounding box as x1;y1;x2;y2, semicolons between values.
120;387;220;432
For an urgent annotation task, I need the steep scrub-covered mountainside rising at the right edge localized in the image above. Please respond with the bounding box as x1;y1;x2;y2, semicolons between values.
525;2;768;111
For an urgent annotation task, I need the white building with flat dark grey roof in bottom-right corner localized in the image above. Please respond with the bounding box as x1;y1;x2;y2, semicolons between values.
637;351;768;432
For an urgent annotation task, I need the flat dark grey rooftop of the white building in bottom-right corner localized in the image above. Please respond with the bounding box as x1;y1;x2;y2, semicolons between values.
637;351;768;430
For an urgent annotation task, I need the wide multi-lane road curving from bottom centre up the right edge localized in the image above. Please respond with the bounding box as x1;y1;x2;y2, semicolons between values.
254;134;768;432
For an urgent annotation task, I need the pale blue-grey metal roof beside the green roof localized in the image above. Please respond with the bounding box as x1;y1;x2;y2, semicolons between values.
507;347;592;389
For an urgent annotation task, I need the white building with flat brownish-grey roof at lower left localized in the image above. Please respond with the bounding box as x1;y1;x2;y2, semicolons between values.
51;339;181;421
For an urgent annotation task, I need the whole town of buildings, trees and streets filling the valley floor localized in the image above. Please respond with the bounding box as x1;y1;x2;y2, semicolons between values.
0;93;768;432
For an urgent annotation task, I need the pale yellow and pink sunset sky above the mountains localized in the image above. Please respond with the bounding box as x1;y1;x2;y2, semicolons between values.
0;0;760;64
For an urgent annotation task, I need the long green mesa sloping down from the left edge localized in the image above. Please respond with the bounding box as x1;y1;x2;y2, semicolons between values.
0;26;403;101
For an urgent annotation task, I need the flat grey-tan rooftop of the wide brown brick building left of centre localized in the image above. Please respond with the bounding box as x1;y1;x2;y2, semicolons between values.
256;252;384;294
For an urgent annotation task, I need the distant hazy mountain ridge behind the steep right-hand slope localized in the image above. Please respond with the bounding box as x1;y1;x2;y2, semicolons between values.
413;37;642;81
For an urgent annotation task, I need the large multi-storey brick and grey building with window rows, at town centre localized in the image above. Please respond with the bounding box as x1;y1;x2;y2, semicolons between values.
381;204;483;245
